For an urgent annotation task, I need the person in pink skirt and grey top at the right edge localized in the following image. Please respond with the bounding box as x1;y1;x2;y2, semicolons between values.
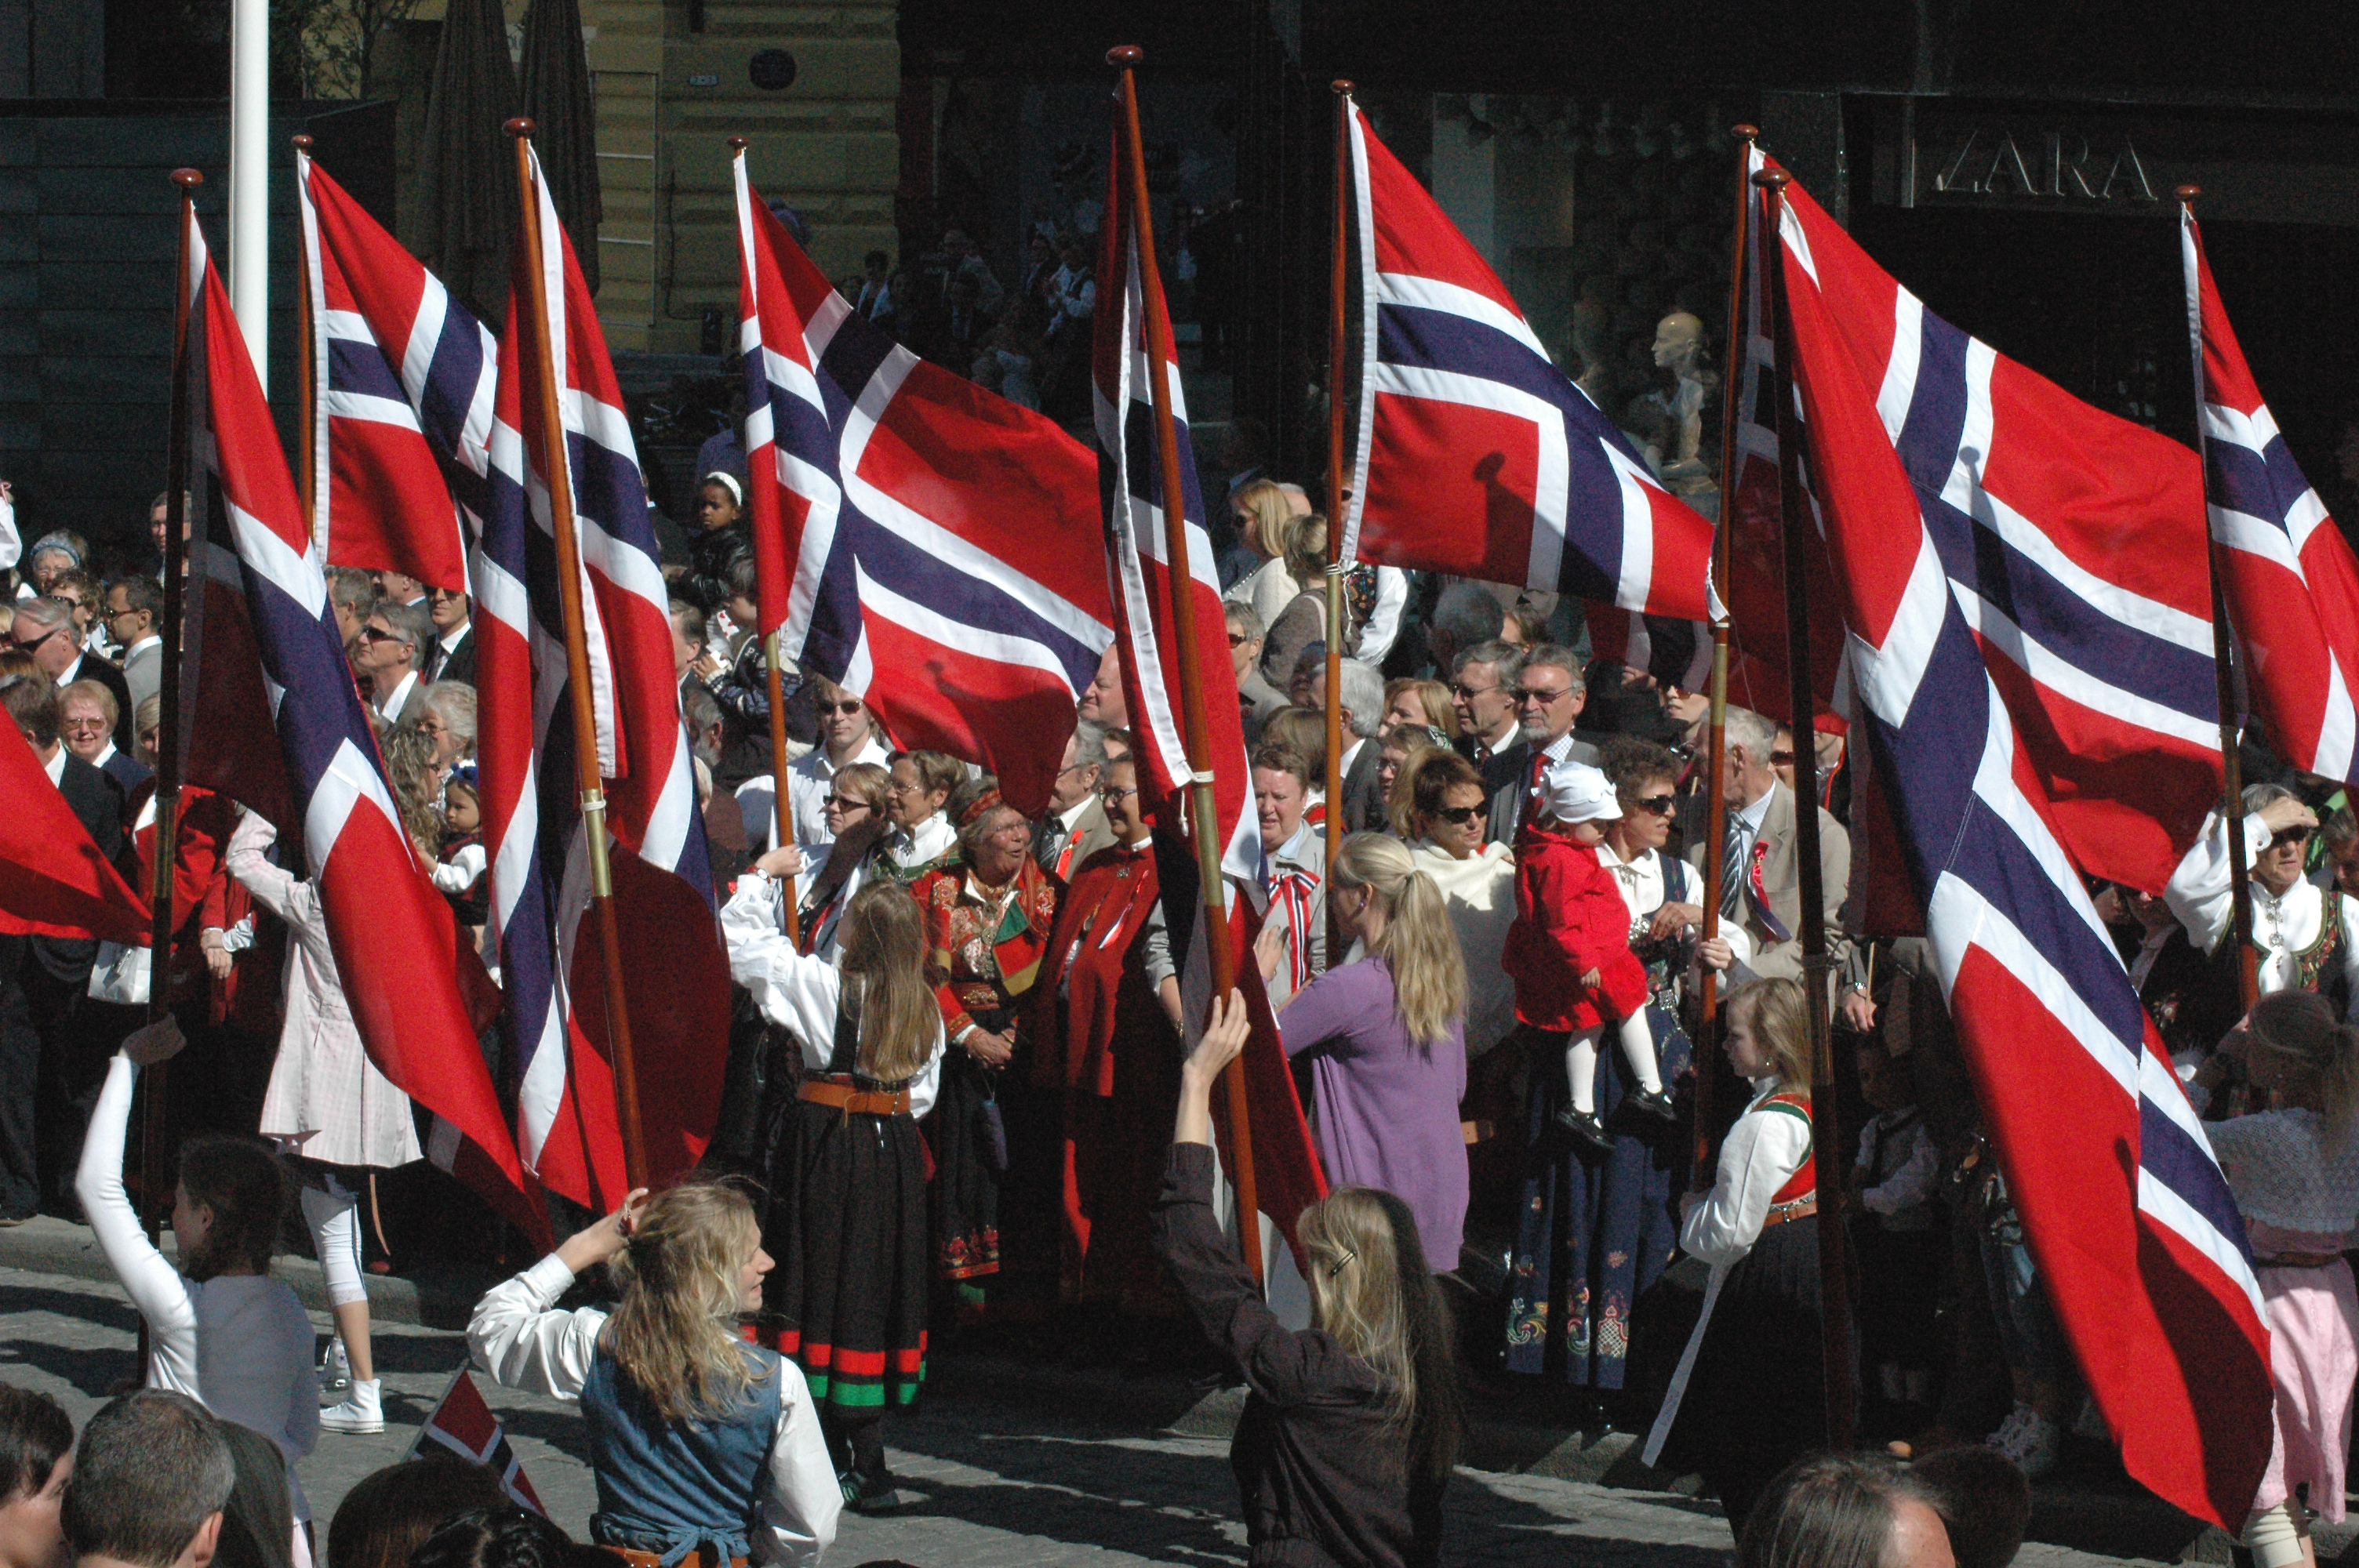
2203;990;2359;1568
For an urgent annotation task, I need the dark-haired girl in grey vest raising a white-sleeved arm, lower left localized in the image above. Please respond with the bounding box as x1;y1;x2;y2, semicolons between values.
73;1014;318;1537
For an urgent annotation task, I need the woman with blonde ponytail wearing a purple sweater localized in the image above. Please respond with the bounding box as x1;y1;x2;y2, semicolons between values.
1259;833;1467;1269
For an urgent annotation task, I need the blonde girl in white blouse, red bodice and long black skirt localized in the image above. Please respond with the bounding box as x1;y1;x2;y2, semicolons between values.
1645;978;1826;1528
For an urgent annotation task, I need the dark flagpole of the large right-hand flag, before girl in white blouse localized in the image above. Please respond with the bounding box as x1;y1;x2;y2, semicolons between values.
1764;170;1856;1453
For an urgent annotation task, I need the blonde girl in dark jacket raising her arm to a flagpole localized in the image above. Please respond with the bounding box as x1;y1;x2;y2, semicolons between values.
1156;993;1465;1566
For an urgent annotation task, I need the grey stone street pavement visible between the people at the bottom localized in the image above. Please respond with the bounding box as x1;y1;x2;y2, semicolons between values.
0;1259;2208;1568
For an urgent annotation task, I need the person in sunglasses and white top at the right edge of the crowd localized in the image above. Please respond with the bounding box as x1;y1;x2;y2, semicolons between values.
2163;782;2359;1016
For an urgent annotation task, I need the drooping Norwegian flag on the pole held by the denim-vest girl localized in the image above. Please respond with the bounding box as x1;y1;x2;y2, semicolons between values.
485;143;729;1207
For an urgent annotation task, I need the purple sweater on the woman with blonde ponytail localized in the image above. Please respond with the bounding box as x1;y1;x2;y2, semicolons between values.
1278;957;1467;1273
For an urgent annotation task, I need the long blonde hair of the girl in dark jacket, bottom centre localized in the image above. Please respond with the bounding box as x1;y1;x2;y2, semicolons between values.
1295;1186;1463;1481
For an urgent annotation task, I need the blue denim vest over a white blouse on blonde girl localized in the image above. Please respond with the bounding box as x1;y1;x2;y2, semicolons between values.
580;1344;786;1568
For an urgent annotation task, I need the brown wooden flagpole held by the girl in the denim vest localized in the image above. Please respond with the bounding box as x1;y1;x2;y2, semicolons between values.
500;115;646;1200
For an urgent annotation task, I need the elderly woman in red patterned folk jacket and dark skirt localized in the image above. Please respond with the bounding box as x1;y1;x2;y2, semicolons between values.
896;764;1062;1311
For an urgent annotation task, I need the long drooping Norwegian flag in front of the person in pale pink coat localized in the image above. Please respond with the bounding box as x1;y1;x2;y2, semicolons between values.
182;205;547;1236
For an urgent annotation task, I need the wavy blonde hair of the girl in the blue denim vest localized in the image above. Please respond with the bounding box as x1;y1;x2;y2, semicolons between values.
606;1188;769;1422
